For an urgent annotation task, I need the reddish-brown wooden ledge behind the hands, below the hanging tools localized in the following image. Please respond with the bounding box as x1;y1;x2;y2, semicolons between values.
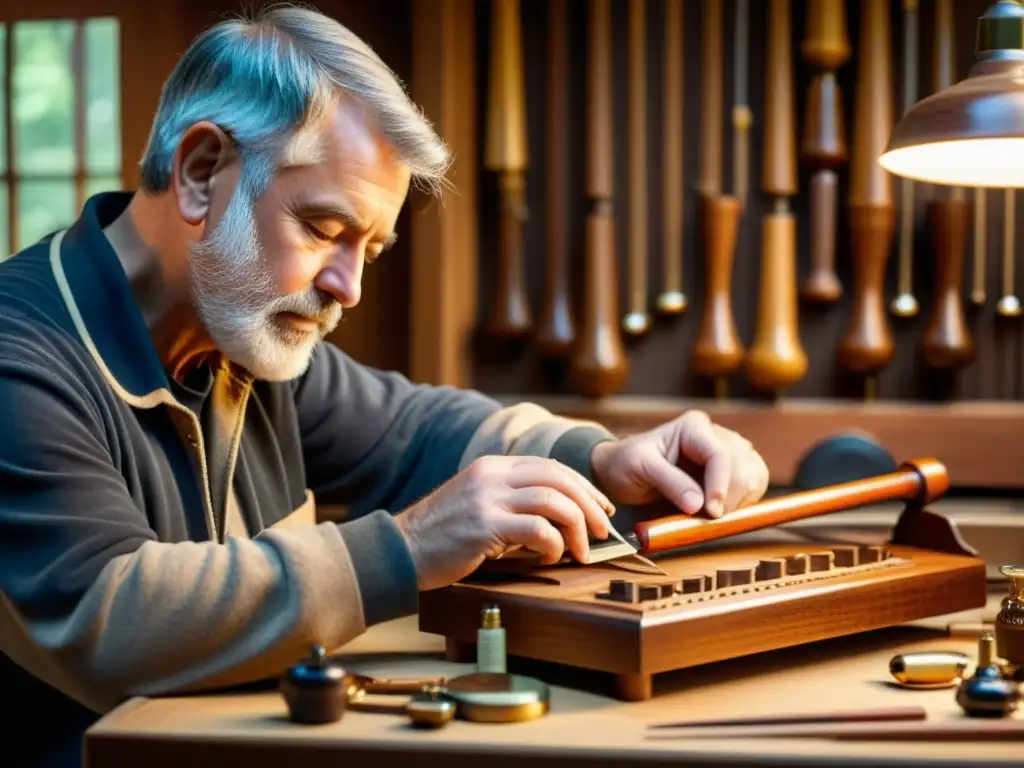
500;395;1024;488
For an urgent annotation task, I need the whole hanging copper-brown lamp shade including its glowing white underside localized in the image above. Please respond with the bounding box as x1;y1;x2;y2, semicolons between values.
879;0;1024;188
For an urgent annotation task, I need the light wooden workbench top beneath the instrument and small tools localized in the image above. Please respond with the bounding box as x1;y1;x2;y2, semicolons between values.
86;590;1024;768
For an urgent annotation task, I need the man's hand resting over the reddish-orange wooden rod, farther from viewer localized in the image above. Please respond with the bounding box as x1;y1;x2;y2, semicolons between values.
591;411;768;517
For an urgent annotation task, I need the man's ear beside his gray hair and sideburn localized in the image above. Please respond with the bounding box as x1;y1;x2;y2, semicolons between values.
173;121;234;225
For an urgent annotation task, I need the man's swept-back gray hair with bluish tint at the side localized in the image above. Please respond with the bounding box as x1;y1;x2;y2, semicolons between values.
139;4;451;200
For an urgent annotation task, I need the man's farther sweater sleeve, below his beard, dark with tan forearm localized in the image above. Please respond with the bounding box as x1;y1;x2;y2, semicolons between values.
295;343;614;516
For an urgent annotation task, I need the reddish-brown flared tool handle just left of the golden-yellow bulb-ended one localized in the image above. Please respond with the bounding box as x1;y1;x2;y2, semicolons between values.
692;196;743;376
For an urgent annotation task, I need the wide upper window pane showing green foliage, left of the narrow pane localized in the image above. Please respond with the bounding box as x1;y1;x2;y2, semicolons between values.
11;22;75;176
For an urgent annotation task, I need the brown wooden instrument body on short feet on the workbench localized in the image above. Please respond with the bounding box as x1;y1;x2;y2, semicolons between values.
420;505;987;700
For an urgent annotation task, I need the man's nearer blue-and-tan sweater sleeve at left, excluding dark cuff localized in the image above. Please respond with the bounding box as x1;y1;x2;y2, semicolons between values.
0;357;374;712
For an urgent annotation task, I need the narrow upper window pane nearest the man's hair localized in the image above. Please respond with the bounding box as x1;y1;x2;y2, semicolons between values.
85;18;121;174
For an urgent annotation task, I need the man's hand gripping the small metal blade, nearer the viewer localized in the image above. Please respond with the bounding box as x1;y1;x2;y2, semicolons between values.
395;456;614;590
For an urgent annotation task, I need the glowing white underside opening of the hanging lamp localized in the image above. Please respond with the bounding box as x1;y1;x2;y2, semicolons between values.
879;137;1024;188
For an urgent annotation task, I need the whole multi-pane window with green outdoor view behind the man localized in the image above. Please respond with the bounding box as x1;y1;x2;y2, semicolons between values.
0;17;121;256
